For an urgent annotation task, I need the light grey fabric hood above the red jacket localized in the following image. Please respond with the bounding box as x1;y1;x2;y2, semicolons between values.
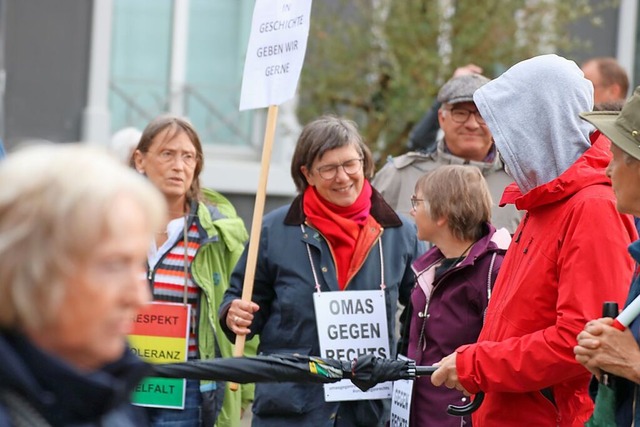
473;55;593;194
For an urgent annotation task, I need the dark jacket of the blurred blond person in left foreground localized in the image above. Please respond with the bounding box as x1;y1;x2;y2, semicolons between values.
0;332;149;427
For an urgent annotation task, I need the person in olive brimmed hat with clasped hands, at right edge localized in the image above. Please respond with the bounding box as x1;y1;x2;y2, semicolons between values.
574;86;640;426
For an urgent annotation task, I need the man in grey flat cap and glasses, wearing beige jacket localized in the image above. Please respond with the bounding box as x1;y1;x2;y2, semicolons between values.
372;74;522;233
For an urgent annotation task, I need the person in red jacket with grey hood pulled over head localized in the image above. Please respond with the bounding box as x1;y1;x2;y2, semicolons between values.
431;55;636;427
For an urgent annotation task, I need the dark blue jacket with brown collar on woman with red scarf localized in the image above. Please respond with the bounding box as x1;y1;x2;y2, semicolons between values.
220;191;424;427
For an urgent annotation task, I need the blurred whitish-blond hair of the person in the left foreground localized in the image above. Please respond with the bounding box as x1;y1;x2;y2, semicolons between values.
0;143;166;330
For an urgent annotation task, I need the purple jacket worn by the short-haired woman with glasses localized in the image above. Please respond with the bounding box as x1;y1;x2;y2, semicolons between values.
408;224;511;427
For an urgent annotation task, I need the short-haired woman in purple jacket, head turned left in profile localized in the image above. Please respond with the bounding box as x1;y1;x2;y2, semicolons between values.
403;165;511;427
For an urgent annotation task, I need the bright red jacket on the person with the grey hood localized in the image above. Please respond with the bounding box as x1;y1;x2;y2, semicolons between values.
456;133;637;427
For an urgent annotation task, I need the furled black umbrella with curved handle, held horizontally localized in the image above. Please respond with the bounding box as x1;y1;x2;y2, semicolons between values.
152;354;484;416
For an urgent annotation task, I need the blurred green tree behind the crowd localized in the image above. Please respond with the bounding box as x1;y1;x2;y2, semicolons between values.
298;0;618;170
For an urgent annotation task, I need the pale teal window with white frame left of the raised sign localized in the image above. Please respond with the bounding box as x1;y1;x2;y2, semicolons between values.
109;0;257;147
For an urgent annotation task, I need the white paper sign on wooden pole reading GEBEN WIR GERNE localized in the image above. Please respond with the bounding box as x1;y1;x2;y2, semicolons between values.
240;0;311;111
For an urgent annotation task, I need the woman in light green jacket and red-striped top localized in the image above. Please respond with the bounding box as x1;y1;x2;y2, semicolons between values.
131;115;255;427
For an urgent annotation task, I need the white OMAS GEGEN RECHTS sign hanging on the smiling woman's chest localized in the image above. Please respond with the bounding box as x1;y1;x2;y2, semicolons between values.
313;290;392;402
